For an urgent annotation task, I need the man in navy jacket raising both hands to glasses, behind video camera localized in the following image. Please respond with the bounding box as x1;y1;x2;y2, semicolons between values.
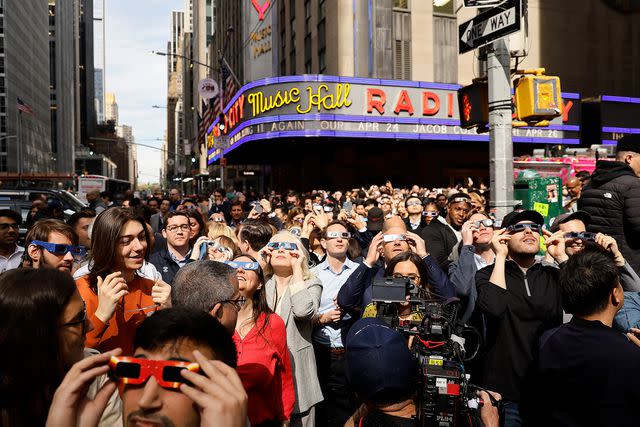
338;217;455;334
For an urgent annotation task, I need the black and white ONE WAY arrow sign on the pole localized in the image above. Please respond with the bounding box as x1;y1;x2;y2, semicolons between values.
458;0;521;53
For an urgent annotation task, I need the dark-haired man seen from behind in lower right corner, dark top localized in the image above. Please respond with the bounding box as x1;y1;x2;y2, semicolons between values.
523;247;640;426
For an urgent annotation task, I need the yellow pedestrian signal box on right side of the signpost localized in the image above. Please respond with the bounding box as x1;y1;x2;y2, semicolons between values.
514;68;562;123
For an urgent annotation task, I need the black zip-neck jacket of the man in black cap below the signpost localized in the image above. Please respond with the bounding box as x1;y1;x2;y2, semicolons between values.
474;260;562;402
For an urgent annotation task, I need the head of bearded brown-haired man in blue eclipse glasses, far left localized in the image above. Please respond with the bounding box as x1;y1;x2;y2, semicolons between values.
25;219;86;274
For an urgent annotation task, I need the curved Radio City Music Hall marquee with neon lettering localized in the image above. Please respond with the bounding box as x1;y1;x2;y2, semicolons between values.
207;75;580;164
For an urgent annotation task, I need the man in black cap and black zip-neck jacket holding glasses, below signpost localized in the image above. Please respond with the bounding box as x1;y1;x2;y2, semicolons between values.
474;211;567;427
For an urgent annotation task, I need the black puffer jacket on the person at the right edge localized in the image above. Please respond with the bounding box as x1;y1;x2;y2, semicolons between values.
578;161;640;271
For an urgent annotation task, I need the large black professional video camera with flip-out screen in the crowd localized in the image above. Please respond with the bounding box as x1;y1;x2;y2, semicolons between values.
372;277;481;427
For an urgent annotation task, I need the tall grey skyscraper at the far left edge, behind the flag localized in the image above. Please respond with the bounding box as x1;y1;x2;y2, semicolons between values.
0;0;52;173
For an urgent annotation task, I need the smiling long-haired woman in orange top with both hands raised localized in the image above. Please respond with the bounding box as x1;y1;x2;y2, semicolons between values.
76;208;171;356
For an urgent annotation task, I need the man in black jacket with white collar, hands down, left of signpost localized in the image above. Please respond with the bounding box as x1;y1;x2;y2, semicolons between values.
420;193;471;270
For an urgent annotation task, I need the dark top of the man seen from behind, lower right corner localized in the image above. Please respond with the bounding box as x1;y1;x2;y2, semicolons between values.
520;317;640;427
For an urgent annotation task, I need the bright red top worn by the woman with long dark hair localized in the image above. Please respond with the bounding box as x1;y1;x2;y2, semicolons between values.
233;314;295;425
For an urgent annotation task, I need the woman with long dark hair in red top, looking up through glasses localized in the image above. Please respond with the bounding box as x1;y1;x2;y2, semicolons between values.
229;255;295;426
